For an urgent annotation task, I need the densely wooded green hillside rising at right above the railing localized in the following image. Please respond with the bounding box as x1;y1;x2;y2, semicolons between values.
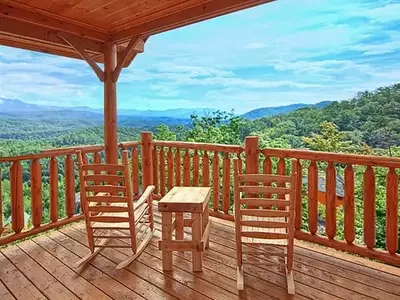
257;83;400;148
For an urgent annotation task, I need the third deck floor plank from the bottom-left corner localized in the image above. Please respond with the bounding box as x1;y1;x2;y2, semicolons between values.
2;246;79;300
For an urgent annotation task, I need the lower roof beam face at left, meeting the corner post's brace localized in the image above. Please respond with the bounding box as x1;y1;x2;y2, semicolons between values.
0;16;104;53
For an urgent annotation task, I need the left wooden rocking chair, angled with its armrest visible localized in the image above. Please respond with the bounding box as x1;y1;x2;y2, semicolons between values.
74;151;154;269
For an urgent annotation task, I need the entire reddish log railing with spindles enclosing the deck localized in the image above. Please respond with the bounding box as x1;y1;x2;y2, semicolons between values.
0;133;400;266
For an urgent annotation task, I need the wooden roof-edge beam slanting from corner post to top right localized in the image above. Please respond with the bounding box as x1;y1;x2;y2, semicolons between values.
113;0;275;43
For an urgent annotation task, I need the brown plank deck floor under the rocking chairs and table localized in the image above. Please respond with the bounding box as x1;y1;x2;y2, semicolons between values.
0;211;400;300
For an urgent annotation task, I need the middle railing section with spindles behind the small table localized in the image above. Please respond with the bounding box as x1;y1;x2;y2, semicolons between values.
152;141;244;220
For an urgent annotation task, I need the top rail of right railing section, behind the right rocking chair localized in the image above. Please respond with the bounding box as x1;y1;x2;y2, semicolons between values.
259;148;400;168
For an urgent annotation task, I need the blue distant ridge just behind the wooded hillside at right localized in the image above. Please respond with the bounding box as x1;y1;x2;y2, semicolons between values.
241;101;332;120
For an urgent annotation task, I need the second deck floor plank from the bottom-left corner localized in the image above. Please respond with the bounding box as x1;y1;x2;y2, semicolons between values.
0;252;46;300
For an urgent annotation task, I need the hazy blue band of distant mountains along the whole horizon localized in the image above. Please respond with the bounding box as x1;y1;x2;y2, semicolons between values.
0;98;330;119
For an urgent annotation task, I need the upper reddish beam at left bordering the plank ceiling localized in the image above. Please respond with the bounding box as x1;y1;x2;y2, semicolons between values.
0;3;107;41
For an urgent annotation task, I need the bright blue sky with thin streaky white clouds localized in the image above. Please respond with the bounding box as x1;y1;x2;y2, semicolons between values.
0;0;400;113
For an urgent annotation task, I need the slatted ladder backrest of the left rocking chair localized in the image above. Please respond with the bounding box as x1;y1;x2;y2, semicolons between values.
77;151;136;251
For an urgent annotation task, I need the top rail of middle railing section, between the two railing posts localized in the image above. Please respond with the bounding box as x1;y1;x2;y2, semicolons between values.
153;140;244;153
